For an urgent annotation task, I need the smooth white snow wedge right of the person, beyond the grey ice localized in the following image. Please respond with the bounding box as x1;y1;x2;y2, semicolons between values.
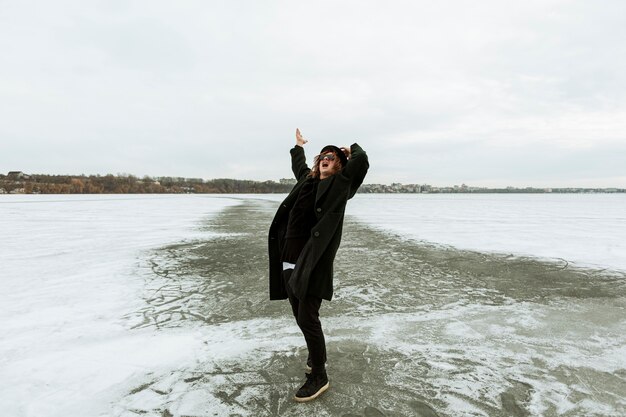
347;194;626;271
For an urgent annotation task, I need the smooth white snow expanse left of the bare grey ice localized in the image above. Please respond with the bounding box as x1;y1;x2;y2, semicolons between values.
0;195;238;417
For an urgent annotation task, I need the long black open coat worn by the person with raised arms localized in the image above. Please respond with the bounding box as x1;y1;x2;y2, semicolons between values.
268;143;369;300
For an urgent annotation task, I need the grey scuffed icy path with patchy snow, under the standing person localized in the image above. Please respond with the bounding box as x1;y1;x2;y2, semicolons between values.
114;200;626;417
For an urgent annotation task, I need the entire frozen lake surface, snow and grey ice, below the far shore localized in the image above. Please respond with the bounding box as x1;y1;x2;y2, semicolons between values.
0;194;626;417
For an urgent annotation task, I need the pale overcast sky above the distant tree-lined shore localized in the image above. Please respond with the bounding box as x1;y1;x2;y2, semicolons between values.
0;0;626;187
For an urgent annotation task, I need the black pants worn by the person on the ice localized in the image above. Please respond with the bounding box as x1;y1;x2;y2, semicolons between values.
283;269;326;374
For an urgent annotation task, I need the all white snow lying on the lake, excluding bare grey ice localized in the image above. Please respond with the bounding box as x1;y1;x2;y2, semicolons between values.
0;194;626;417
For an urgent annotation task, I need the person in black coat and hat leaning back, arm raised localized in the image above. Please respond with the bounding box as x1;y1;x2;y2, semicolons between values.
268;129;369;402
